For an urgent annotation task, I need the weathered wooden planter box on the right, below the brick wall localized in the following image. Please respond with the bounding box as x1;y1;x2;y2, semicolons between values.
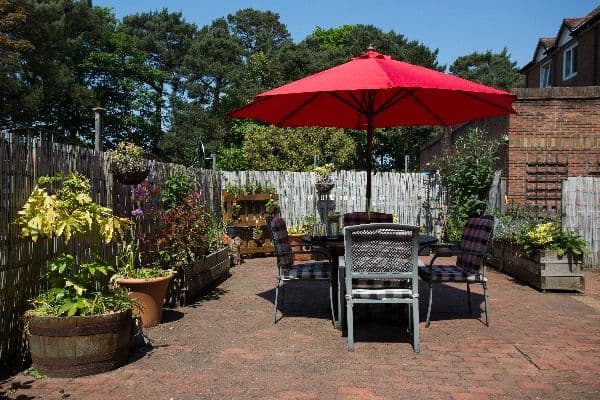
491;243;585;291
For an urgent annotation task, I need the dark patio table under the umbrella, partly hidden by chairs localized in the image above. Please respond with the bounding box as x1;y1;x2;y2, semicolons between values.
302;235;437;330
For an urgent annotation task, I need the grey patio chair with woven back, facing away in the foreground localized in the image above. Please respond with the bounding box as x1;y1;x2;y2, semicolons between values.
340;223;420;353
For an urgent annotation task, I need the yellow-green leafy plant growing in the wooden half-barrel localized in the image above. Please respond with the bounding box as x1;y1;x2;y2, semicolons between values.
14;173;131;316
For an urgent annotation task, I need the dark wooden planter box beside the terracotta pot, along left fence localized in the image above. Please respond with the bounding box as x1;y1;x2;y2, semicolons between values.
166;247;230;307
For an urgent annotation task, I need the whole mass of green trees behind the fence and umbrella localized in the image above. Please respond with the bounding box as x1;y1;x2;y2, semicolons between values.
0;0;516;170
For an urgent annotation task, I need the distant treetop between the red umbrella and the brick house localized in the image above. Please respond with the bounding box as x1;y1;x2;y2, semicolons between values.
450;47;525;90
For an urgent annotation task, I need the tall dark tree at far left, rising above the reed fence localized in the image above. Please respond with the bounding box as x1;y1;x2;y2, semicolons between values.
0;0;110;142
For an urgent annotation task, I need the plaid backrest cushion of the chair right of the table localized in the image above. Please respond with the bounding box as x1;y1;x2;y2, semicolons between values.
456;217;494;274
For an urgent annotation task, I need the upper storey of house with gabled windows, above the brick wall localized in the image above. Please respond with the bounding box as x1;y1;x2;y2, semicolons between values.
520;7;600;88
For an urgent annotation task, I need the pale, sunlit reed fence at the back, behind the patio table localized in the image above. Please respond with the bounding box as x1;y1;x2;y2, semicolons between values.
222;171;444;231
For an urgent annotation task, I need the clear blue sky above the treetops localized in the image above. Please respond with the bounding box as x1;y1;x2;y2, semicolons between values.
93;0;600;67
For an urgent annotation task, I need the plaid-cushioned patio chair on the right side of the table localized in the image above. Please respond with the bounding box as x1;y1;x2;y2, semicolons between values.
419;215;494;327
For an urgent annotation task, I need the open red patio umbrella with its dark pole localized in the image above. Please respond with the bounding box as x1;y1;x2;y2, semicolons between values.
230;48;516;211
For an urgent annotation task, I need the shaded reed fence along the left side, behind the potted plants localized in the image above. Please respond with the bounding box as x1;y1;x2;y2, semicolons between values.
0;133;221;376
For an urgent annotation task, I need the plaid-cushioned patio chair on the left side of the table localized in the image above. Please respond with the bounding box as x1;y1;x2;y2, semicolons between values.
267;217;335;323
